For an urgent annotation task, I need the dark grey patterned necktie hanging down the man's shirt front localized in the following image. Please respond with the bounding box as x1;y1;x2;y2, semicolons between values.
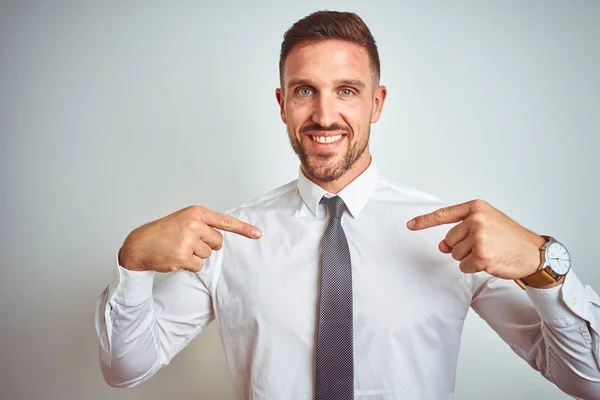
315;196;354;400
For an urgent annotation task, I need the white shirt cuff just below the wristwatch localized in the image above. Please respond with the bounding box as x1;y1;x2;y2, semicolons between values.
526;270;589;327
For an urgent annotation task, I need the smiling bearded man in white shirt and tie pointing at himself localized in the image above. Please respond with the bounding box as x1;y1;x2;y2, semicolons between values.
97;12;600;400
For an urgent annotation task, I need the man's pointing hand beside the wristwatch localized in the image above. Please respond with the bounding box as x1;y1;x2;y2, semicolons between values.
407;200;546;279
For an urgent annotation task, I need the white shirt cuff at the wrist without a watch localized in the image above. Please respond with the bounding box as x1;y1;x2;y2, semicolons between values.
108;252;155;307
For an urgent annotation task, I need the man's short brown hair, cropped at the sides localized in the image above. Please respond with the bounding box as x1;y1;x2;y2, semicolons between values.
279;11;381;85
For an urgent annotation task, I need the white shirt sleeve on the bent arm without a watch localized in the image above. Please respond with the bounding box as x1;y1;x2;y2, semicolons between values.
96;250;222;387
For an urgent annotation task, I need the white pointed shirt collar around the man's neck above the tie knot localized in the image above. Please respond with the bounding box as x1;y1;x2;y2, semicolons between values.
298;159;380;218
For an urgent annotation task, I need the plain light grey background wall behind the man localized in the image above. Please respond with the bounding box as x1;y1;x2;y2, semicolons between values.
0;0;600;400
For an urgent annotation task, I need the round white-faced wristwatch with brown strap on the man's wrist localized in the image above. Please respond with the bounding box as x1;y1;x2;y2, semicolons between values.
515;235;571;290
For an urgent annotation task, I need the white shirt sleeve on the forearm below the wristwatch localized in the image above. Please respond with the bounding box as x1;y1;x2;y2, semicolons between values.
471;271;600;399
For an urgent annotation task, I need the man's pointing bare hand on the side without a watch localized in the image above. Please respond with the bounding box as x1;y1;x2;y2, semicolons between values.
119;206;262;272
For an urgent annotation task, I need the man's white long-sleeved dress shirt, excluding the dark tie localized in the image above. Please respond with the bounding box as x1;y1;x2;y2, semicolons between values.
96;162;600;400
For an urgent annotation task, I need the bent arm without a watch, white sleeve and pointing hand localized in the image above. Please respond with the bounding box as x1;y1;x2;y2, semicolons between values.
96;206;260;387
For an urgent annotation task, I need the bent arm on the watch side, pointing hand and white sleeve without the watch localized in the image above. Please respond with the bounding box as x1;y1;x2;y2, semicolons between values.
407;200;600;399
